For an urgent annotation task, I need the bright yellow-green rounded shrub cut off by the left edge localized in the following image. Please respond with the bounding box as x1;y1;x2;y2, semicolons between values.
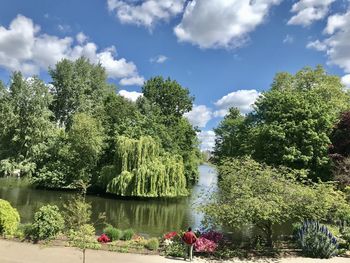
0;199;19;236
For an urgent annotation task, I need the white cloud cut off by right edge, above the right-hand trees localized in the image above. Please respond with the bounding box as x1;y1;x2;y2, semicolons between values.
307;10;350;80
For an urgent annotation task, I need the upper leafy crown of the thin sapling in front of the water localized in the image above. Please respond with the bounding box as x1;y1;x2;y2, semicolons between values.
62;195;92;229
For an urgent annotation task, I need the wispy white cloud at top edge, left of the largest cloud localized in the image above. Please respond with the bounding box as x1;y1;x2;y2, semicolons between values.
107;0;185;29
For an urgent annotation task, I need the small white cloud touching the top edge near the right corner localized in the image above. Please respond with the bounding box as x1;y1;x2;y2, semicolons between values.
288;0;336;26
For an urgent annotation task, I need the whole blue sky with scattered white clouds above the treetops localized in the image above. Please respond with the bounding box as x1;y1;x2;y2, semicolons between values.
0;0;350;150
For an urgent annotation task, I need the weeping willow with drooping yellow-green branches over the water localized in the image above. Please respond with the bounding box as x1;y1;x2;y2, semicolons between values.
100;136;188;197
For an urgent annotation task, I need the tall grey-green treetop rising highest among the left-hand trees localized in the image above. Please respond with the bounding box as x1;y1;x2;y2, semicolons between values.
49;57;112;128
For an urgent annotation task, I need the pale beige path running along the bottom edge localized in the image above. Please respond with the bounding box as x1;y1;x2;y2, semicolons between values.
0;240;350;263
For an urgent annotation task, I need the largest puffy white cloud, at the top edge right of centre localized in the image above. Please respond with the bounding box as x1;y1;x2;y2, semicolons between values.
174;0;282;48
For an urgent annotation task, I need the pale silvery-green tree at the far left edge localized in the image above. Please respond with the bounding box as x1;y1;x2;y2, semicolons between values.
0;72;54;174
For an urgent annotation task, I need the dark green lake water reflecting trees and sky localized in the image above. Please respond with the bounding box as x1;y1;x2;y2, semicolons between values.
0;165;217;236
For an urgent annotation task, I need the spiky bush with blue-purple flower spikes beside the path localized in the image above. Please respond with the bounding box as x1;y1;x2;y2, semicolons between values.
297;221;338;258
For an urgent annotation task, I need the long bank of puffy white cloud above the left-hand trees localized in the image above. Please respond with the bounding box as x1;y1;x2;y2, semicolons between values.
0;15;142;85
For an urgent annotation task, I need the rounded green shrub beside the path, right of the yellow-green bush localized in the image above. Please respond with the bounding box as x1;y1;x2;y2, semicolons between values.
33;205;64;240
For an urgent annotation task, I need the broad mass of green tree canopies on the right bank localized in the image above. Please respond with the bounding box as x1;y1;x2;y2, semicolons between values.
215;67;349;181
